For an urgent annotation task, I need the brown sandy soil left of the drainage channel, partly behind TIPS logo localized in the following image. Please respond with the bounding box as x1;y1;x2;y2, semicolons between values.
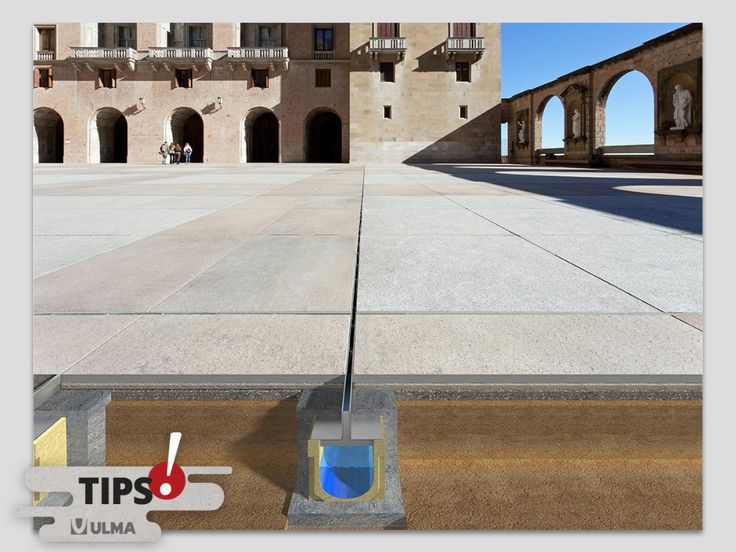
107;401;296;530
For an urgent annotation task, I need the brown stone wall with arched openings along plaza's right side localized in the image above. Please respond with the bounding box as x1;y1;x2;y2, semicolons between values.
502;23;703;170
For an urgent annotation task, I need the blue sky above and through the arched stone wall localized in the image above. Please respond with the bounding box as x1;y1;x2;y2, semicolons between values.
501;23;686;154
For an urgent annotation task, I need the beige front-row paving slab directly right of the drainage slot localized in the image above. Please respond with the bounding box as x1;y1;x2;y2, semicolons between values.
354;314;703;383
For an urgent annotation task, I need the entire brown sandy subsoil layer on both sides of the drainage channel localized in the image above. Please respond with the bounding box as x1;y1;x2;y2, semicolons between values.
107;401;702;530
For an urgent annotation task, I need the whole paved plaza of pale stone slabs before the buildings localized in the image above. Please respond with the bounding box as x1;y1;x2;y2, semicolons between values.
33;164;703;384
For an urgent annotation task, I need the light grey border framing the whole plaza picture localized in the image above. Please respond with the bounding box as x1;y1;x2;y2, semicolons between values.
0;0;736;552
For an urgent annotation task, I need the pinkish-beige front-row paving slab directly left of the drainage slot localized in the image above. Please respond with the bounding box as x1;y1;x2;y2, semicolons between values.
62;315;350;381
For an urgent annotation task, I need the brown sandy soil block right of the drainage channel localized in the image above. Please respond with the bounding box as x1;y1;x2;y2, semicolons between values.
399;401;702;529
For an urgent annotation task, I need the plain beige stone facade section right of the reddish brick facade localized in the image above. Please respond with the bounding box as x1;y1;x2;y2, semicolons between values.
350;23;501;163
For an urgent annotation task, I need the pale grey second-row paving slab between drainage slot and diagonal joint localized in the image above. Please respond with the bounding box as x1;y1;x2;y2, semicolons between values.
358;235;654;313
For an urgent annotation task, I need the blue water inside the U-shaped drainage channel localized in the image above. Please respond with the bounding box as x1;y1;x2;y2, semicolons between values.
319;445;373;498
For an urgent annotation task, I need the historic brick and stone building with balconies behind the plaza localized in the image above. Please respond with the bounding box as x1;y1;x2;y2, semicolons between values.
33;23;501;163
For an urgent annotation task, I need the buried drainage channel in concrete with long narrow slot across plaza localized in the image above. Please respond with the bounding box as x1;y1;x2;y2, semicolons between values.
287;165;406;529
